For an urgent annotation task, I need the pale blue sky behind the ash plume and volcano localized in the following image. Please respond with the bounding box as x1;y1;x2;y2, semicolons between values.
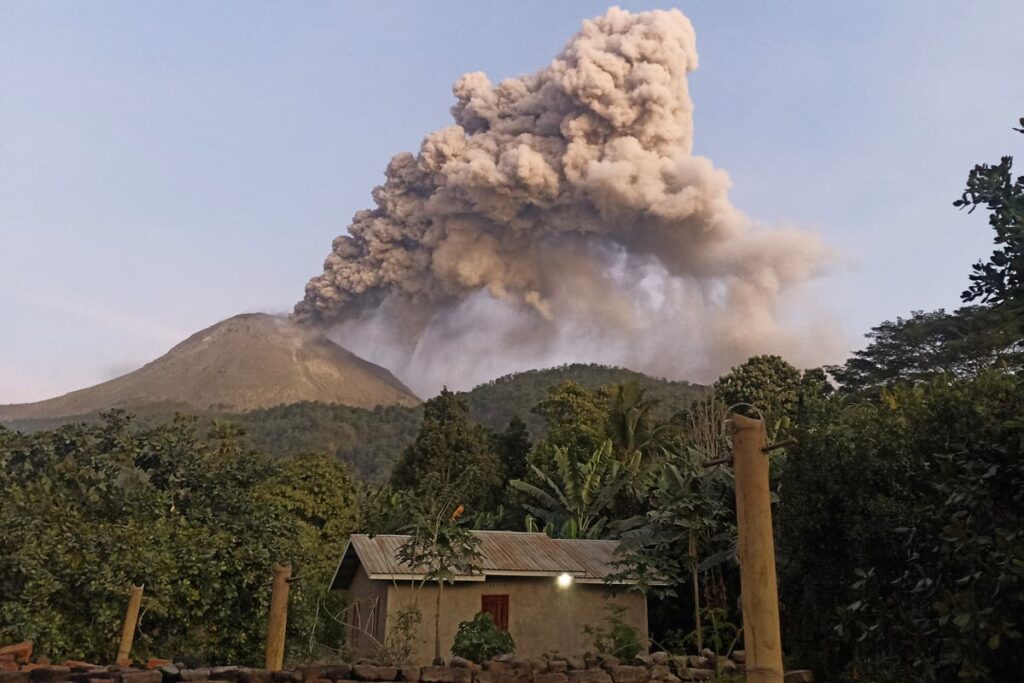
0;0;1024;403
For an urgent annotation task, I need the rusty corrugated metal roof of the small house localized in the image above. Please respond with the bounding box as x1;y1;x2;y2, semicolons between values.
332;531;643;587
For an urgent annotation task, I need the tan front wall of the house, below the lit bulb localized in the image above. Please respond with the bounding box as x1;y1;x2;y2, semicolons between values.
381;577;647;665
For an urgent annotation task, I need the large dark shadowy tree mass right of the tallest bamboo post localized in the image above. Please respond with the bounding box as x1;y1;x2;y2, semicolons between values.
778;371;1024;681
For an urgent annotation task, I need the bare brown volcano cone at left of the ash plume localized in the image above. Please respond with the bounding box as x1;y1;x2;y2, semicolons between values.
0;313;420;422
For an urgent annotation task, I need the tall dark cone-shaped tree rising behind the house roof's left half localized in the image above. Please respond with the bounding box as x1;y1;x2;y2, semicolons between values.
391;389;501;510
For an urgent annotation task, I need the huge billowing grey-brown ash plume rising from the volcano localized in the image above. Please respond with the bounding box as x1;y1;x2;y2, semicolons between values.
295;8;825;395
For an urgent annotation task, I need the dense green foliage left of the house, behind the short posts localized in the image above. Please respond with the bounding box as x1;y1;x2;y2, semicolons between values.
0;413;354;663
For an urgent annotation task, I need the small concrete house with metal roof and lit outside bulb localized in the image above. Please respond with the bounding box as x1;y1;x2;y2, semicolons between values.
331;531;647;665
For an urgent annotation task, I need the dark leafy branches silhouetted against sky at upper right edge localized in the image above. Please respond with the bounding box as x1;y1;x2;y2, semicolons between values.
953;118;1024;305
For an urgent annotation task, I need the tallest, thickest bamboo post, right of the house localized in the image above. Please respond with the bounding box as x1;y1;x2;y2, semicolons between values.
731;415;782;683
